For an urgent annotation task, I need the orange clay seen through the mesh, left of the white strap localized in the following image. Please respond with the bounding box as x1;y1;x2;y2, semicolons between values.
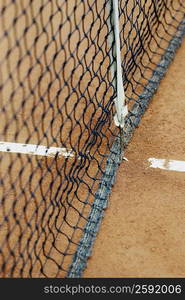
0;0;112;277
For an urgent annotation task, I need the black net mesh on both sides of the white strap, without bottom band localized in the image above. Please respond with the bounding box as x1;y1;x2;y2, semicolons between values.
0;0;185;277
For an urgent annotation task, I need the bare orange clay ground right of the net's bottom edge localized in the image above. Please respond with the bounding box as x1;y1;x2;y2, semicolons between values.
83;35;185;277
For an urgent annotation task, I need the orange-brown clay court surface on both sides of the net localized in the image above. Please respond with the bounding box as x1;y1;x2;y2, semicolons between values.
0;0;185;277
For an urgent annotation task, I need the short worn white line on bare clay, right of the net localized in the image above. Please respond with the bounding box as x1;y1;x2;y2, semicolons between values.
148;158;185;172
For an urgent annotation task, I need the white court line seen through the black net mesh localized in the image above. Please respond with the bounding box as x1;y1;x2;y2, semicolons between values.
0;141;74;157
